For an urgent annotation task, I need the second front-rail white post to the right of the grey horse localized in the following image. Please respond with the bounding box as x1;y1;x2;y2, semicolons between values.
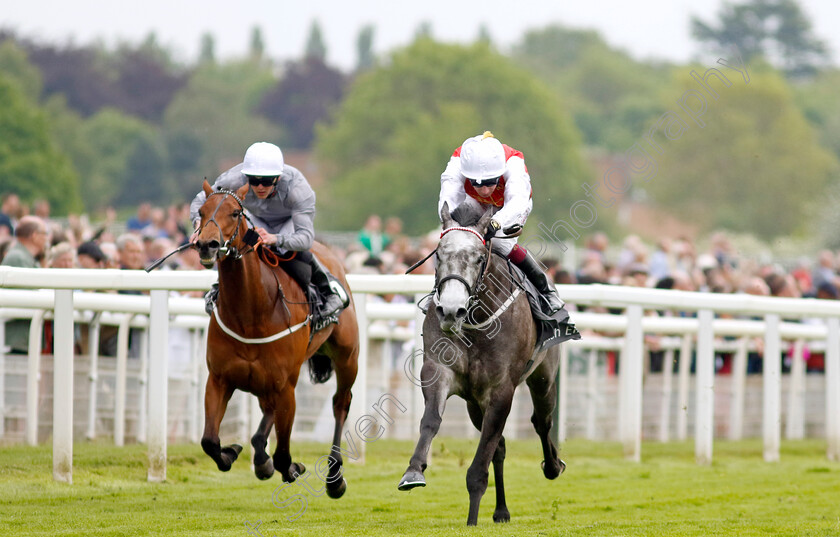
694;310;715;464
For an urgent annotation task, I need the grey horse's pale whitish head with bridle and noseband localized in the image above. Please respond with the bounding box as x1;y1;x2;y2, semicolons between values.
435;203;492;332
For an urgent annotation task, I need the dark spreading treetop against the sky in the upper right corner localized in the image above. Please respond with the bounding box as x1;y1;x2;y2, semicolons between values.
691;0;829;77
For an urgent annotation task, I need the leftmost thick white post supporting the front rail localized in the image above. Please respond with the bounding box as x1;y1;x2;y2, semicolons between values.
53;289;75;483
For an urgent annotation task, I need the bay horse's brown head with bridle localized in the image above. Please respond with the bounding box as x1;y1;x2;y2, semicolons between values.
195;181;249;268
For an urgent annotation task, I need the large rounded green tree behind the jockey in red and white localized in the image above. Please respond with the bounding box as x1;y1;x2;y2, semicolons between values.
317;39;586;233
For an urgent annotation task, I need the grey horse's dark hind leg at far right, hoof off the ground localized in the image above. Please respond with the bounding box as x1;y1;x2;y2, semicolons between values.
526;354;566;479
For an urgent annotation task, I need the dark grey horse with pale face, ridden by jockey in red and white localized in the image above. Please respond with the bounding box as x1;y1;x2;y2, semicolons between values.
398;204;566;526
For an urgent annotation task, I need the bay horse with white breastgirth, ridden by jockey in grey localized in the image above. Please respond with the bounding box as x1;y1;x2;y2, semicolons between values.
195;181;359;498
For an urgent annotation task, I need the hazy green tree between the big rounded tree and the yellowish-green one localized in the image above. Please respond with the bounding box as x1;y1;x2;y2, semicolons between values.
513;26;669;151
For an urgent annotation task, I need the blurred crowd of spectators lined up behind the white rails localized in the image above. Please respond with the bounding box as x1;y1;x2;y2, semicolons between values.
0;194;840;370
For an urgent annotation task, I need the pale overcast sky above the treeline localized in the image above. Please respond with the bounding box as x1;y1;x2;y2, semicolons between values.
0;0;840;70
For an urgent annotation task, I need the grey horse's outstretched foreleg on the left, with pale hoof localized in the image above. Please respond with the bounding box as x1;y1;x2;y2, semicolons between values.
397;362;452;490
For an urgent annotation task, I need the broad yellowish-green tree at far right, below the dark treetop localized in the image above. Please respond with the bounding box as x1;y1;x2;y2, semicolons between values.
642;66;838;239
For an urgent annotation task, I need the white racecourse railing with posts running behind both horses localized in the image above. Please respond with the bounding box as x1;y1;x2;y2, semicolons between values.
0;267;840;481
